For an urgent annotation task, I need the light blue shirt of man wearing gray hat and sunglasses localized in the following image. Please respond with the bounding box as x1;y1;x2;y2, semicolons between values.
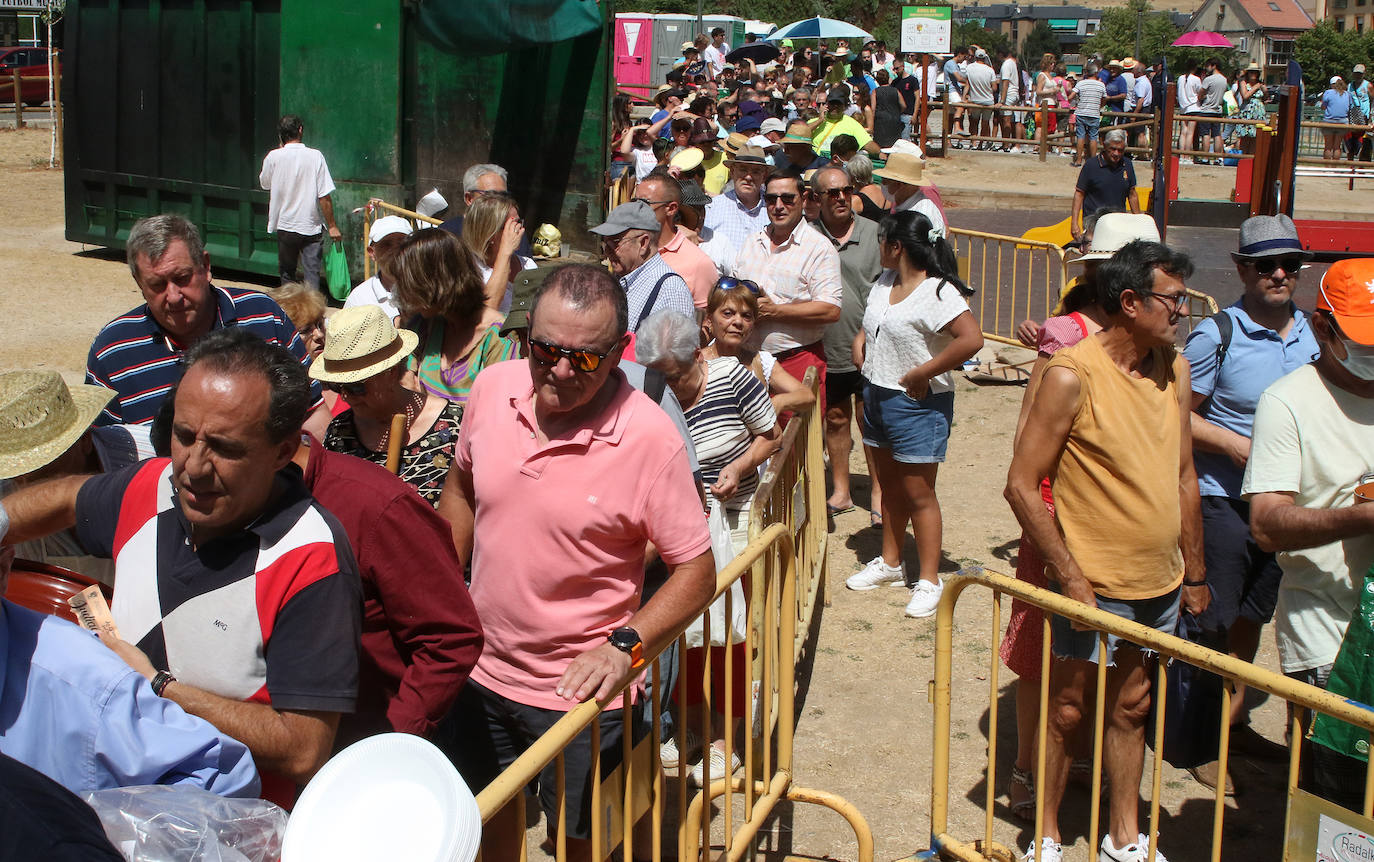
1183;301;1322;499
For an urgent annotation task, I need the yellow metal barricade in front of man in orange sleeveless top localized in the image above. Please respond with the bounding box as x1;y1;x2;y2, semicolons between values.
930;568;1374;862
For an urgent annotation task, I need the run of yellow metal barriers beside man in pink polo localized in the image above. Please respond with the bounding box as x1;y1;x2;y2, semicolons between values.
477;373;872;862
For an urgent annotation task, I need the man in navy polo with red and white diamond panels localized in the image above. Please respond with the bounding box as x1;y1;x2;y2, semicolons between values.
3;327;361;806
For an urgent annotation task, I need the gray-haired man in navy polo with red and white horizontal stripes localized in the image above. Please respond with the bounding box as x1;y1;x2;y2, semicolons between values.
85;214;330;437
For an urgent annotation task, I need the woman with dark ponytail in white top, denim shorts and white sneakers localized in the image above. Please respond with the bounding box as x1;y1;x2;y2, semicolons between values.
845;212;982;617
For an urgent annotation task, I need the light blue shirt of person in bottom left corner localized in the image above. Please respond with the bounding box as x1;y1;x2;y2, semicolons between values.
0;599;258;797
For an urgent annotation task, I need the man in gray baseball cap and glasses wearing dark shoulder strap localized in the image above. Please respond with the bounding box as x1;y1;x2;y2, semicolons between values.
591;201;695;333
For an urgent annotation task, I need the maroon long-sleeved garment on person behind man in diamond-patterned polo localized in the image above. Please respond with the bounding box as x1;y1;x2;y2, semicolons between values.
305;437;482;748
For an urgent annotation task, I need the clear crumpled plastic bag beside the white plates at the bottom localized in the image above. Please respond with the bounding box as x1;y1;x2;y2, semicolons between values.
82;785;286;862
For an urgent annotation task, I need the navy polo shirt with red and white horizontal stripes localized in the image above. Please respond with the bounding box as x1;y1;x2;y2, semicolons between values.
87;285;322;425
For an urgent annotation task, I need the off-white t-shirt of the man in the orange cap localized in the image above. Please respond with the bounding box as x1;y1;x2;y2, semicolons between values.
1242;362;1374;674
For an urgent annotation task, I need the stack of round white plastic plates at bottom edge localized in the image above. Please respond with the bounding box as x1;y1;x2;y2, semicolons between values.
282;733;482;862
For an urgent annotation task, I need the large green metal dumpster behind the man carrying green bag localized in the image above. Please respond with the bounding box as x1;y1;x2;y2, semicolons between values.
63;0;613;276
